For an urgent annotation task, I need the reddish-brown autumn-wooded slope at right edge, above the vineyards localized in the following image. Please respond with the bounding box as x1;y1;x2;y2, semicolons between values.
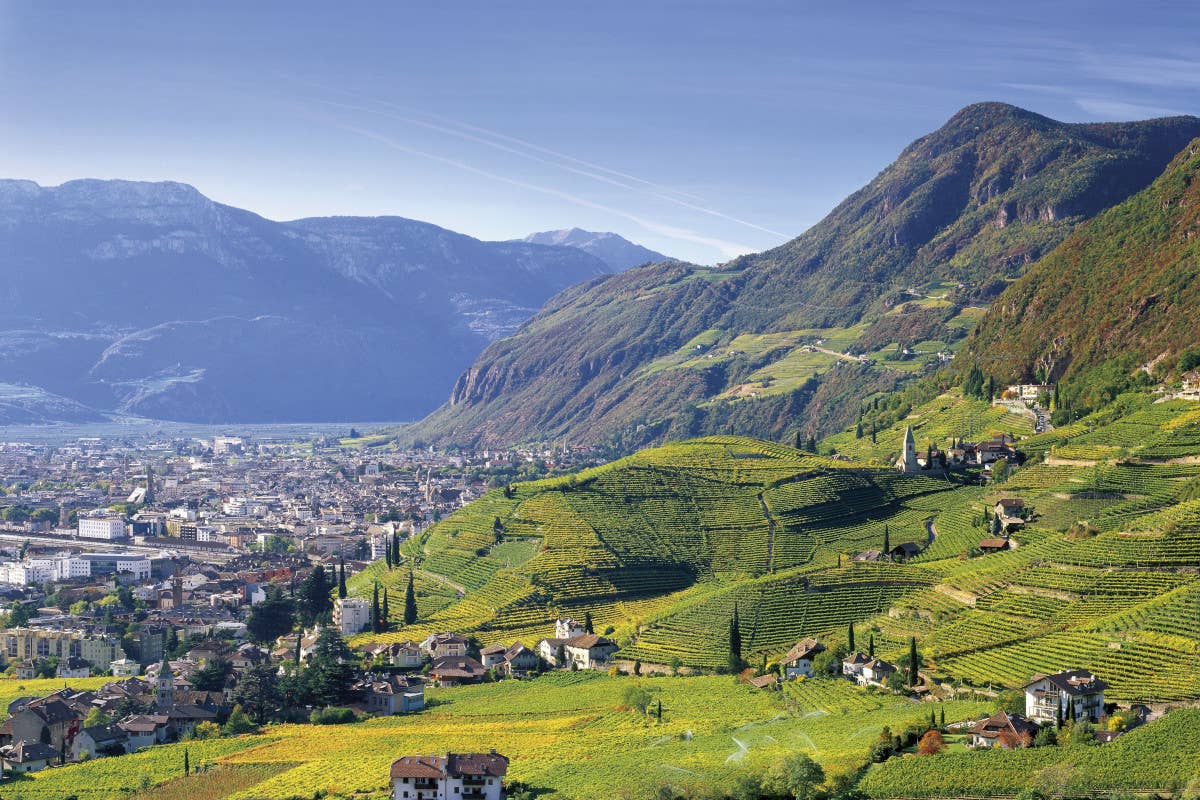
956;139;1200;411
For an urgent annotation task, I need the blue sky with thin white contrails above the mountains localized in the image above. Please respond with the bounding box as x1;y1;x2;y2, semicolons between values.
0;0;1200;264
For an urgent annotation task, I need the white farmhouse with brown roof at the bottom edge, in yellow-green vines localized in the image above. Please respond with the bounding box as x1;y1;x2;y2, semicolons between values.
391;750;509;800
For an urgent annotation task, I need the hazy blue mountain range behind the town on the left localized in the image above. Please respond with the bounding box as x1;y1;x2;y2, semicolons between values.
0;180;608;422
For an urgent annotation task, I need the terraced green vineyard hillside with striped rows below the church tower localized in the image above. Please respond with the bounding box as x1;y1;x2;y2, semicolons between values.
354;395;1200;700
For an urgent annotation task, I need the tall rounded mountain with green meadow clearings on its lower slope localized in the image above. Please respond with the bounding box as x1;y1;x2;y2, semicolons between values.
412;103;1200;451
